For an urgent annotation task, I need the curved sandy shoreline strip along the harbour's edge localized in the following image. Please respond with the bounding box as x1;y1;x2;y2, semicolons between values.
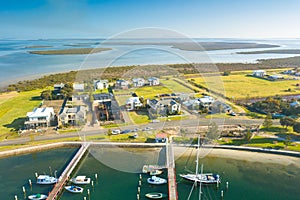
0;142;300;168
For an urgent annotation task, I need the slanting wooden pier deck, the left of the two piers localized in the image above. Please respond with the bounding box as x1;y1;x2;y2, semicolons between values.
47;144;90;200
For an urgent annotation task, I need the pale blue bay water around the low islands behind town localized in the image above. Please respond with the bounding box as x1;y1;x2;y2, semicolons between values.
0;39;300;85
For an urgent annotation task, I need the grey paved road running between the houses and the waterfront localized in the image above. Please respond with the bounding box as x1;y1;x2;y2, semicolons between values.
0;118;279;146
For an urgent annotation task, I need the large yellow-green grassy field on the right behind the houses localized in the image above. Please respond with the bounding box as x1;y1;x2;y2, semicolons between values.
188;70;300;99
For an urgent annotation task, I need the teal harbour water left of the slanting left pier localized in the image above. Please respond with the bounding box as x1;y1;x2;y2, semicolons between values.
0;148;76;200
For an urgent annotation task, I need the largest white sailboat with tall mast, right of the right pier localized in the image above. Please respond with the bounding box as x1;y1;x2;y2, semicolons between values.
179;136;221;184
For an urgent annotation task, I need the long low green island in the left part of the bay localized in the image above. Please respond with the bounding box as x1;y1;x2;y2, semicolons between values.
29;48;112;55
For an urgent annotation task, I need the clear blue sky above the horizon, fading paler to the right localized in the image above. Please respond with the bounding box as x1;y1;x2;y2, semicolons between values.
0;0;300;39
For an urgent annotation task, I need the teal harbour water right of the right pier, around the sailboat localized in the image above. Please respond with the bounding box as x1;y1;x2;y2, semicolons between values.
176;156;300;200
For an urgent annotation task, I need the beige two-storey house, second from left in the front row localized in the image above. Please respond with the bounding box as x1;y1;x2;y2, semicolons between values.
59;106;87;126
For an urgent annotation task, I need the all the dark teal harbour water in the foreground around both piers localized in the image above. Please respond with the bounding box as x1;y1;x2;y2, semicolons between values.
0;148;300;200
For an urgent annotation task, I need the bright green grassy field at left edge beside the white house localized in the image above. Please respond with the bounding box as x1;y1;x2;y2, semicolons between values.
0;90;42;139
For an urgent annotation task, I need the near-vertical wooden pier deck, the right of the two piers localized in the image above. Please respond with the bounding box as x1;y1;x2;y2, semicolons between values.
166;140;178;200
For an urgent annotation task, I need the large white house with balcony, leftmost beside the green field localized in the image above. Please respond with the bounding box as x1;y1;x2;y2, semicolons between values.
24;107;54;129
